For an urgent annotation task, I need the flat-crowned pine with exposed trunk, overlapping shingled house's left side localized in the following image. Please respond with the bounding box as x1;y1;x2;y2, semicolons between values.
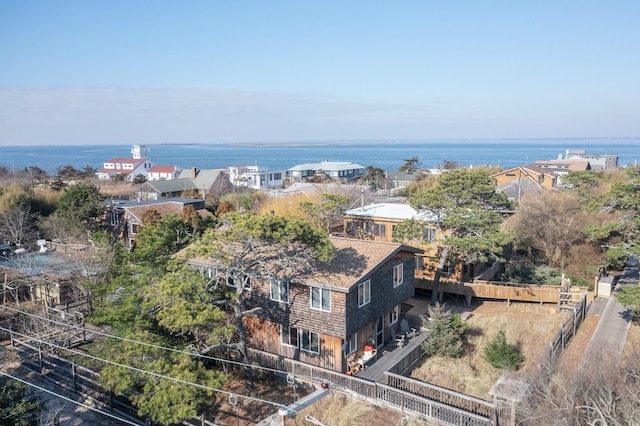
187;212;333;386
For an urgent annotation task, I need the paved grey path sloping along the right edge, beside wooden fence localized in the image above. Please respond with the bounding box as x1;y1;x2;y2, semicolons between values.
581;257;639;368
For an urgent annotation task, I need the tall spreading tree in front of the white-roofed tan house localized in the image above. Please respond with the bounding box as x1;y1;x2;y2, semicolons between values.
398;169;512;303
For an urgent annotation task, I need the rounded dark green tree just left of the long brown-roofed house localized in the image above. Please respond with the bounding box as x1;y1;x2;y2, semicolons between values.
56;184;105;230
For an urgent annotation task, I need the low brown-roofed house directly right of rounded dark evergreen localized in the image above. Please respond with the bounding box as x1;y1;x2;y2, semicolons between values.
107;198;211;248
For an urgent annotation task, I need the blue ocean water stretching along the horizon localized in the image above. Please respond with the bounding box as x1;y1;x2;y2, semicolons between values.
0;138;640;174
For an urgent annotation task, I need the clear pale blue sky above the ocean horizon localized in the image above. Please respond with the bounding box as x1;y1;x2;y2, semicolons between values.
0;0;640;145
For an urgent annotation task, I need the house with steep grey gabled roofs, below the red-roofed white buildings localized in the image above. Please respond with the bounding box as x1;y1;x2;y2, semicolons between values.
138;167;233;201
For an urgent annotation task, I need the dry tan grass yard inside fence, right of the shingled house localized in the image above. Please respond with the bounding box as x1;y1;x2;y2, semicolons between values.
411;302;567;399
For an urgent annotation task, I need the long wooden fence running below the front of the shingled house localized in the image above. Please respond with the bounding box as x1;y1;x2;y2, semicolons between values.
248;349;492;426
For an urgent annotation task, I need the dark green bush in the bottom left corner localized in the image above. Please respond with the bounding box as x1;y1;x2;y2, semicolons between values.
0;372;44;426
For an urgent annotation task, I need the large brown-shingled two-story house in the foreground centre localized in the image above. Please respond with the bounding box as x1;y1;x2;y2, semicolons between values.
182;237;420;372
